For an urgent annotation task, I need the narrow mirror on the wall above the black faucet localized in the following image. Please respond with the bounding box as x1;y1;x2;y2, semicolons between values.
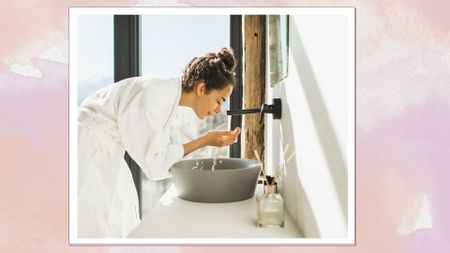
267;15;289;87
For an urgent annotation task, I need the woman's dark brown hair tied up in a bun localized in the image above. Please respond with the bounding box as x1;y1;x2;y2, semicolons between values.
181;48;236;93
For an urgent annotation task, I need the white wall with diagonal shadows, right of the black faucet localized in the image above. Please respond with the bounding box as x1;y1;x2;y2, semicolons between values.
266;8;355;238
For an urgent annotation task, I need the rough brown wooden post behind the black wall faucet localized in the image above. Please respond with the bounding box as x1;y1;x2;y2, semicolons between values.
241;15;266;161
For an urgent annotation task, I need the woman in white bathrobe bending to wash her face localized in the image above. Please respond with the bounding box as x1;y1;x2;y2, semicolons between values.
78;48;240;237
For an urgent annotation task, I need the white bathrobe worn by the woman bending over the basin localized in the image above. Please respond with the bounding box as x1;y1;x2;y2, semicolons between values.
78;77;184;238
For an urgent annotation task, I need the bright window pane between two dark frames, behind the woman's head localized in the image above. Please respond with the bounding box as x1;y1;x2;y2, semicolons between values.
141;15;230;157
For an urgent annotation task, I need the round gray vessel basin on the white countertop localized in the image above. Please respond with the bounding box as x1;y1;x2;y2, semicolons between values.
170;158;259;203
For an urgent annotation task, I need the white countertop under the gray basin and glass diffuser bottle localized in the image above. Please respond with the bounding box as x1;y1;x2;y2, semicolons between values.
128;185;302;238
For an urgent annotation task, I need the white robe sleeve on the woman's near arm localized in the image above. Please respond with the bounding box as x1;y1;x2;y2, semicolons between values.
118;111;184;180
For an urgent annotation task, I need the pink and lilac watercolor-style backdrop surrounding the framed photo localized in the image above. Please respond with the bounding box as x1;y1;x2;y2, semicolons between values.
0;0;450;253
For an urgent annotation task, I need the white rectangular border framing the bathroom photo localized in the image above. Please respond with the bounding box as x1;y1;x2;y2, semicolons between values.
69;6;356;246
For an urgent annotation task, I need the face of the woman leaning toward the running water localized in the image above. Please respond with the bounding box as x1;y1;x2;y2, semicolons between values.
194;83;233;119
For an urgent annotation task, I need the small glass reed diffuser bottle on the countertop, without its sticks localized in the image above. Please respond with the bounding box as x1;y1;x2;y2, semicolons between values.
256;184;284;228
